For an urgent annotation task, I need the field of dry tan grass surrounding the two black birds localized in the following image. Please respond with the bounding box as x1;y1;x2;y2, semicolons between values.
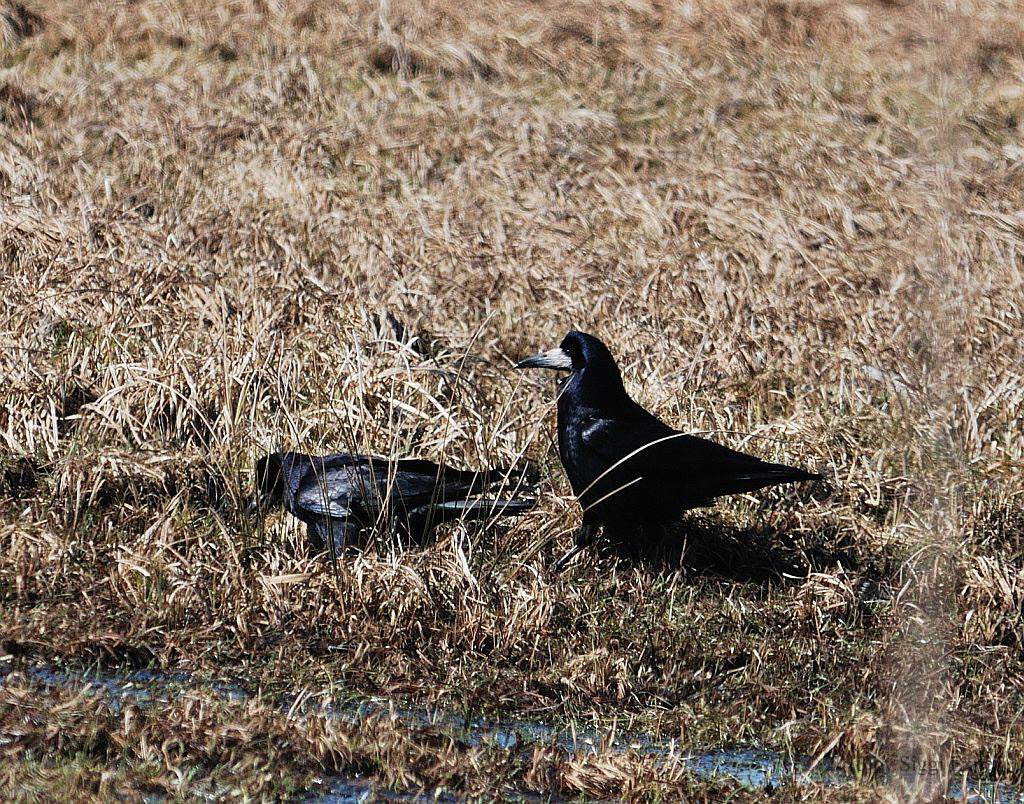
0;0;1024;800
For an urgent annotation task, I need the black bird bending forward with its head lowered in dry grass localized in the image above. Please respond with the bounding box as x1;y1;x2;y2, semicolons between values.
250;453;537;558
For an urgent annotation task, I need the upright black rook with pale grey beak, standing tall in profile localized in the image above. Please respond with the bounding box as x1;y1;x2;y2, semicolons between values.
516;332;821;570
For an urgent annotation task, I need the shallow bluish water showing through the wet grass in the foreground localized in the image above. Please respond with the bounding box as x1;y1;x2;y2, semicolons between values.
0;668;1024;804
